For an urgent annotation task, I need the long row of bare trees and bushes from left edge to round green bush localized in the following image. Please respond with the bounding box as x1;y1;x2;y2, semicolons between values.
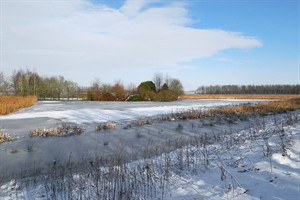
0;69;183;101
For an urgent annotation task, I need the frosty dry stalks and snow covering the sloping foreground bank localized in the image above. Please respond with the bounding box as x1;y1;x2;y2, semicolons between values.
0;112;300;199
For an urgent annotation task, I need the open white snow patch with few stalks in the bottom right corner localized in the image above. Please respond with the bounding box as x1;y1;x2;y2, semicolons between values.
165;125;300;200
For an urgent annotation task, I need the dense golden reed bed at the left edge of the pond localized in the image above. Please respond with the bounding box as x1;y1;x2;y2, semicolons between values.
0;96;37;115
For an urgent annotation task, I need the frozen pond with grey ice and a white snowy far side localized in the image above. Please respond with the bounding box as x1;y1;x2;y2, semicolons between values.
0;99;257;178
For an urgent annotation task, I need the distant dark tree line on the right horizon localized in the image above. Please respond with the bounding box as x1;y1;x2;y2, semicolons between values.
196;84;300;94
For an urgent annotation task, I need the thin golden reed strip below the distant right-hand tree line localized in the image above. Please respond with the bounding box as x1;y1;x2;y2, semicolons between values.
179;94;300;100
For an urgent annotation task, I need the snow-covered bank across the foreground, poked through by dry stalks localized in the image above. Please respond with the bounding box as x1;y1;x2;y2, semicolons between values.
0;113;300;200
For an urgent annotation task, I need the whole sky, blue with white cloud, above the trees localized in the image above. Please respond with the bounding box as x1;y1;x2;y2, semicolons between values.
0;0;300;90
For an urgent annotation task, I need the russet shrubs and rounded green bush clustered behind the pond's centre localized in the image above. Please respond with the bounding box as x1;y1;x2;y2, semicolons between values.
87;73;183;101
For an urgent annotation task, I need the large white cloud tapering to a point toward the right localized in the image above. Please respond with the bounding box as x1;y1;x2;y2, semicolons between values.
1;0;261;83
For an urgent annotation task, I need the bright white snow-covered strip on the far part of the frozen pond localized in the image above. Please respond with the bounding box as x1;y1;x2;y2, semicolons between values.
0;99;258;124
